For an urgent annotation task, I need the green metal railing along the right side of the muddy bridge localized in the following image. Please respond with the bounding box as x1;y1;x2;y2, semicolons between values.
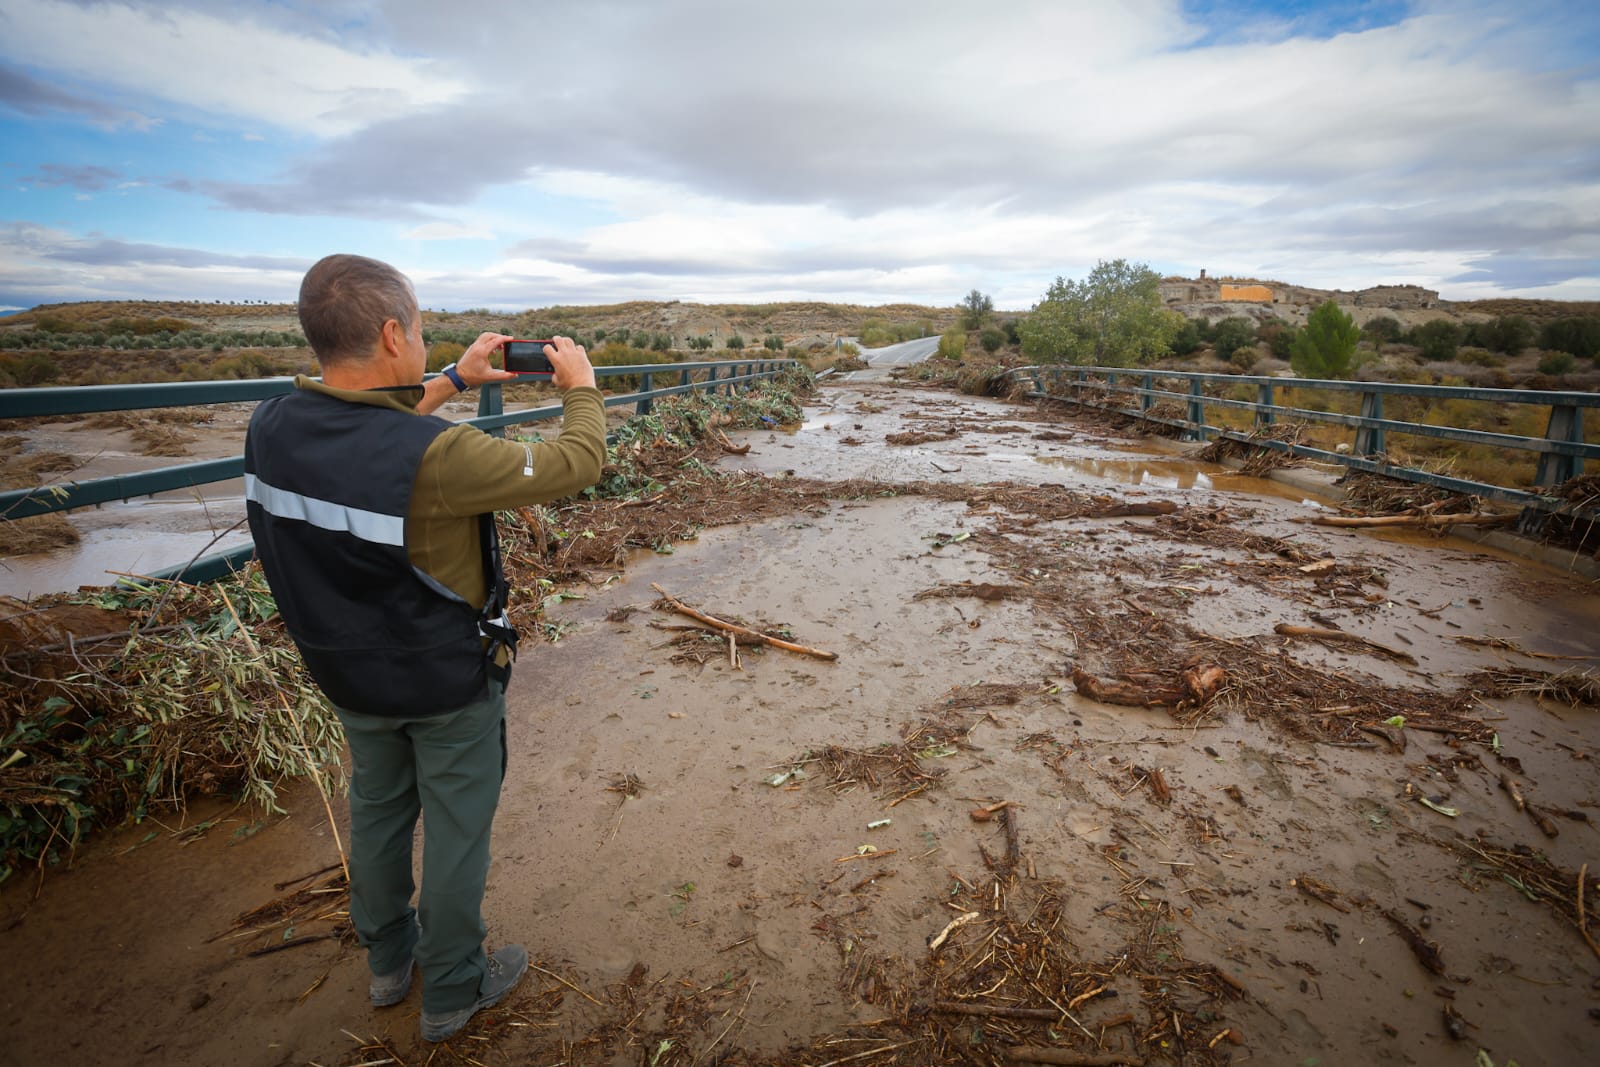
1008;365;1600;515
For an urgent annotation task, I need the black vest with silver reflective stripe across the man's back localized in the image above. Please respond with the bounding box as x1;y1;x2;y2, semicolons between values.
245;389;517;718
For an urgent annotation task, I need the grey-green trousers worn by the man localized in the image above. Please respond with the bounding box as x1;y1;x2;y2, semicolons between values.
334;681;506;1013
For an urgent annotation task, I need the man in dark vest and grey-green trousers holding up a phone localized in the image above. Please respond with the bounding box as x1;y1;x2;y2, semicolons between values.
245;254;605;1041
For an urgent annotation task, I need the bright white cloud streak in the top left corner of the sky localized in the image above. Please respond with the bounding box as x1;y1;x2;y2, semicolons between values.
0;0;464;136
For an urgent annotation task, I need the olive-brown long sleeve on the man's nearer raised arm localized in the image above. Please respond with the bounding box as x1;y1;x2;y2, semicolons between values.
411;387;605;518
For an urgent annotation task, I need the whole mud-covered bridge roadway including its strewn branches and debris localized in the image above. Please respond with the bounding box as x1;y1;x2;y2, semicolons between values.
0;382;1600;1067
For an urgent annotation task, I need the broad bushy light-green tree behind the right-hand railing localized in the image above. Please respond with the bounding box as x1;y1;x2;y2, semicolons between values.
1018;259;1182;366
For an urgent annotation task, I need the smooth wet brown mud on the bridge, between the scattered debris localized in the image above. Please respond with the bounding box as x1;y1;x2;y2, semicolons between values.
0;384;1600;1067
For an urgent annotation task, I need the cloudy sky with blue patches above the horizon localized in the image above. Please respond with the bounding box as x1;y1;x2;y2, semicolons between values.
0;0;1600;309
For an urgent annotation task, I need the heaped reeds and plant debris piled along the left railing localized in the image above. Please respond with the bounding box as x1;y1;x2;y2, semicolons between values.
0;371;813;881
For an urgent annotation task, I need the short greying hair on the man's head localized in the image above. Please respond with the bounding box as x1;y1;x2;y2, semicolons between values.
299;253;419;365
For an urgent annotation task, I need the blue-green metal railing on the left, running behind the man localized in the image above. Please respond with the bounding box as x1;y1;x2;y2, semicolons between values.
0;358;798;582
